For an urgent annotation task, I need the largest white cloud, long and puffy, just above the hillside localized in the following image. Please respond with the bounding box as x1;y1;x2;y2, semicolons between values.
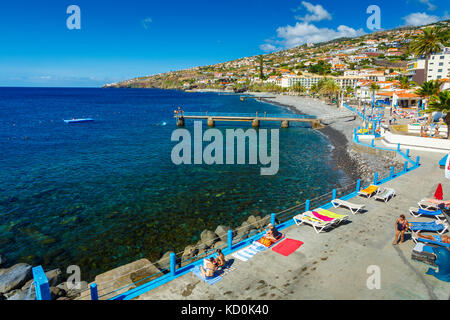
277;22;365;48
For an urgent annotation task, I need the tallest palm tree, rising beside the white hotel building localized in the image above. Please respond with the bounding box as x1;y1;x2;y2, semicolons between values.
410;27;449;81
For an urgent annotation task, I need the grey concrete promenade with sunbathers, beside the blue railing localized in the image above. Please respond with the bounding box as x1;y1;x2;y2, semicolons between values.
136;149;450;300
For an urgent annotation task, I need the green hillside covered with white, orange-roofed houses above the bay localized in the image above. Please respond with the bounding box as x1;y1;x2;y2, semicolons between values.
104;20;450;106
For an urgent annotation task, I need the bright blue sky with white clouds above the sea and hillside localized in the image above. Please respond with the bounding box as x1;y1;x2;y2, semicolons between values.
0;0;450;87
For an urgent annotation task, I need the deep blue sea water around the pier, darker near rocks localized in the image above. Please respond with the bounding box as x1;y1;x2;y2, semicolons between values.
0;88;346;280
